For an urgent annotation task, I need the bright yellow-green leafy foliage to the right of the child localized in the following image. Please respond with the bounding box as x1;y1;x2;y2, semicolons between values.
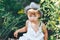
40;0;60;40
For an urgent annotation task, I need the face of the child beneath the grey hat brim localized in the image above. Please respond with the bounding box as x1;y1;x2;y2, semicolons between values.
27;9;40;21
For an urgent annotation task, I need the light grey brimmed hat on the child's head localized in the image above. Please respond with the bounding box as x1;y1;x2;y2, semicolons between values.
24;2;43;16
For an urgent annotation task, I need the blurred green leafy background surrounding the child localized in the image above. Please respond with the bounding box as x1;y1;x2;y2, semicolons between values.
0;0;60;40
